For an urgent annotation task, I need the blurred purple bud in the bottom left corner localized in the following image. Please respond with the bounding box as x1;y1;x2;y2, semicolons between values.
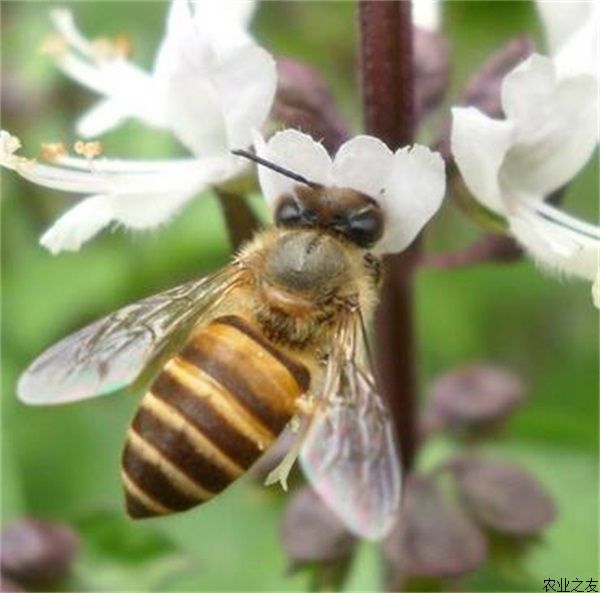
0;518;78;591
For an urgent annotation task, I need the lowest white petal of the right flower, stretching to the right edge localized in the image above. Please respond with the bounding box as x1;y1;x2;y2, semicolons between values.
508;205;600;292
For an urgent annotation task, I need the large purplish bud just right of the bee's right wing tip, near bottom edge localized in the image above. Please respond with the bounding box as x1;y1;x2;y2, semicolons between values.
383;475;487;590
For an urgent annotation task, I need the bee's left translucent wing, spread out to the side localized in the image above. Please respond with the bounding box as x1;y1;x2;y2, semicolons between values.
17;266;237;405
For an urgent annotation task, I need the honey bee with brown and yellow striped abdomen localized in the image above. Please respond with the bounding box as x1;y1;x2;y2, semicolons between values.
18;151;400;539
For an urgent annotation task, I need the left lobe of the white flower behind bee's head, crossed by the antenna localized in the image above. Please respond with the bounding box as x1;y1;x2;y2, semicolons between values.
254;130;332;208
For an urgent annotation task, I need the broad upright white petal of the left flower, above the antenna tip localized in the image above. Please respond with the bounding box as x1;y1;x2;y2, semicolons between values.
155;2;277;156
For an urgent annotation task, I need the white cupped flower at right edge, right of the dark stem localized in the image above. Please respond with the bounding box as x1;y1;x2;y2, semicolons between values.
452;55;600;302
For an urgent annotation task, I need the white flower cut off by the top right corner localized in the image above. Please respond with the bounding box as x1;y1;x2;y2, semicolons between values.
537;0;600;77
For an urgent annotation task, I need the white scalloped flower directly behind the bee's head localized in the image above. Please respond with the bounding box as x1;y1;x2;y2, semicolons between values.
255;130;446;253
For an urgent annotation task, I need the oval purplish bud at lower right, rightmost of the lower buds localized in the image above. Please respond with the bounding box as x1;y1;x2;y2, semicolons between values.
451;457;556;537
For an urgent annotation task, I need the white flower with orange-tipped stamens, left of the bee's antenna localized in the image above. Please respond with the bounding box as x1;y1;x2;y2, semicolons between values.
0;0;276;253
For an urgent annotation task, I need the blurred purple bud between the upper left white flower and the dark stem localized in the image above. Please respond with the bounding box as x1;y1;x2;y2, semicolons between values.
272;58;349;152
